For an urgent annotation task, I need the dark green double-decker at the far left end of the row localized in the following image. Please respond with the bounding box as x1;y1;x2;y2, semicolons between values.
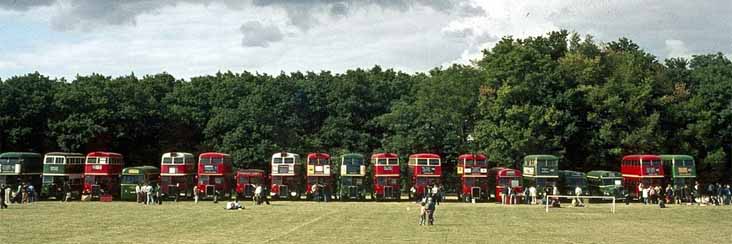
0;152;43;192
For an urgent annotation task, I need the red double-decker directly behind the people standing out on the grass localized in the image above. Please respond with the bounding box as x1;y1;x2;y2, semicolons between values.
408;153;442;199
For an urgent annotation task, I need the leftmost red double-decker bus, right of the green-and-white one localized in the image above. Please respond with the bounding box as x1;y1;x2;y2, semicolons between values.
83;152;124;198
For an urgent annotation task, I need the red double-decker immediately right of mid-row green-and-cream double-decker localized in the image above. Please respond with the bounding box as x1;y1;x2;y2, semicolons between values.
371;153;402;201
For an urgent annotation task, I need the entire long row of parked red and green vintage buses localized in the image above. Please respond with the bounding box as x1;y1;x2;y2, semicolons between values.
0;152;696;201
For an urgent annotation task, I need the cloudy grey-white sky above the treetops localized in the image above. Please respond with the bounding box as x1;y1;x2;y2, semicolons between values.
0;0;732;79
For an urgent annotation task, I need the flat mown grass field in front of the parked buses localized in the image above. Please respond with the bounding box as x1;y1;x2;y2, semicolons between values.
0;202;732;244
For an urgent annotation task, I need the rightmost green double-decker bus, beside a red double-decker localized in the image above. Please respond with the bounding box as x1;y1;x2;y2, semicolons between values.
659;155;696;188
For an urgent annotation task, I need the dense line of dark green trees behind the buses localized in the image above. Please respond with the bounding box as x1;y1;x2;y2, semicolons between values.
0;31;732;179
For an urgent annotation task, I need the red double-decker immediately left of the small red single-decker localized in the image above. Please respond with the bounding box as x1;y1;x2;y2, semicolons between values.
198;152;233;198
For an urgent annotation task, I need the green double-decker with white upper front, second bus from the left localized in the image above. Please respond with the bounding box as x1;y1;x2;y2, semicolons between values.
41;152;85;199
